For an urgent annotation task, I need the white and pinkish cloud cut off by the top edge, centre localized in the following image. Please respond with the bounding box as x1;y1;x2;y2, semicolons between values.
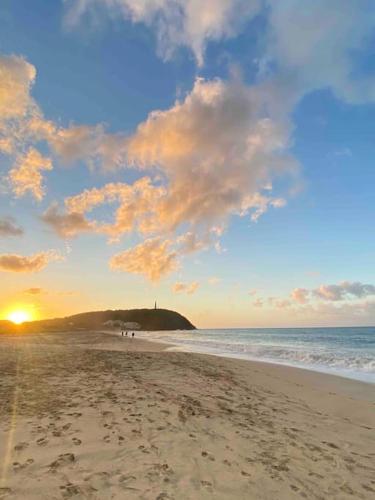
65;0;261;66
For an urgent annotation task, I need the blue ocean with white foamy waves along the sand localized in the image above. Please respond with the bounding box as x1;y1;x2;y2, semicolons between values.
137;327;375;383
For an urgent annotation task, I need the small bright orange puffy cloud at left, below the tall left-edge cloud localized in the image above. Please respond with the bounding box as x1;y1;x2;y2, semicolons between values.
8;147;52;201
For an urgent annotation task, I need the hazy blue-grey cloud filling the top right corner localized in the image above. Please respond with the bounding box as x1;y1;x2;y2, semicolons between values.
267;0;375;103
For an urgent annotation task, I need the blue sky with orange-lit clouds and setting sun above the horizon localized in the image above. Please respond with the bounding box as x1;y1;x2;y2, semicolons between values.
0;0;375;328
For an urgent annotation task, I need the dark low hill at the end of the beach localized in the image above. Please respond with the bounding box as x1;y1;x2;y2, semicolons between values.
0;309;195;333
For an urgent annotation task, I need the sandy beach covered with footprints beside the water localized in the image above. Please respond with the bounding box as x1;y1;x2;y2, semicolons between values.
0;332;375;500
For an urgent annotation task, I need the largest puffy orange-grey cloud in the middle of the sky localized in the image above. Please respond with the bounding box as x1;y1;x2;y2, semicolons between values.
128;75;297;230
